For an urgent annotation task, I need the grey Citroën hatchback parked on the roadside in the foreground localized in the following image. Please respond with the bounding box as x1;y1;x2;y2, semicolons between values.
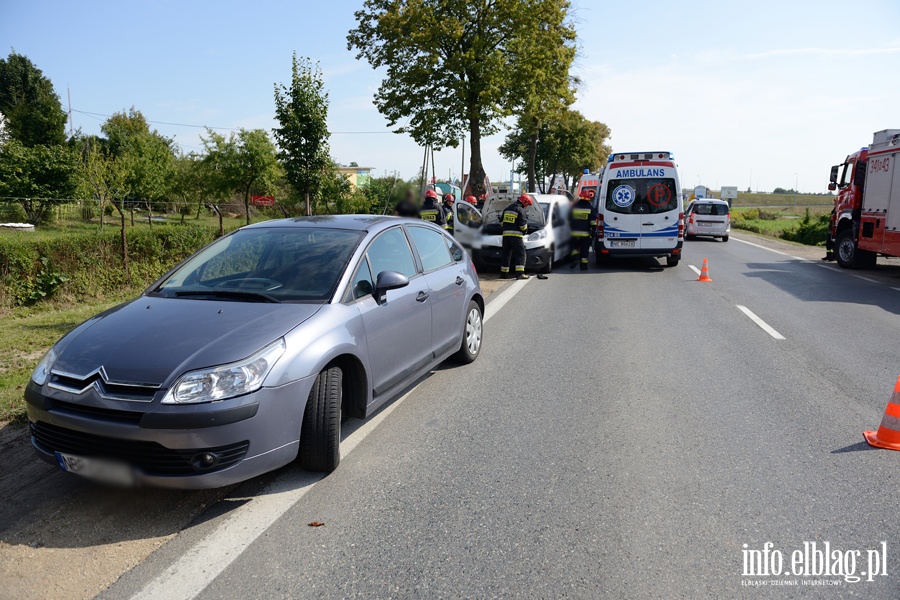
25;215;484;489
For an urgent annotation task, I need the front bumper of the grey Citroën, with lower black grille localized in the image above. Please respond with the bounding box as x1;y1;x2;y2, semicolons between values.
25;377;314;489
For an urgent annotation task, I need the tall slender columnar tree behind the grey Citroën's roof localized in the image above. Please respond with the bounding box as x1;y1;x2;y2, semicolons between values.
272;53;334;215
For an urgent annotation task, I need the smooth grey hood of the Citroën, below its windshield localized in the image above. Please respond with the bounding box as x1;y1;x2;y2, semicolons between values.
52;296;321;385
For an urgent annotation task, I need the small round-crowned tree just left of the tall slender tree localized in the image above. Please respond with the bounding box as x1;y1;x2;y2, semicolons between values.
200;129;280;225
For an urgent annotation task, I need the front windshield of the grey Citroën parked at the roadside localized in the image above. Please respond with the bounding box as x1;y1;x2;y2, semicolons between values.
150;227;364;302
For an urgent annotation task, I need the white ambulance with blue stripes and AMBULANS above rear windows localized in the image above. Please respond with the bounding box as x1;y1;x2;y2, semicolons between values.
594;151;684;267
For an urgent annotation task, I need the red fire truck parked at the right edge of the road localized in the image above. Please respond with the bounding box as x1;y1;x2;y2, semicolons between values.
828;129;900;269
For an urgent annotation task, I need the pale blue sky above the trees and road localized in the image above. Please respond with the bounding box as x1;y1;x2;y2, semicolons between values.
0;0;900;192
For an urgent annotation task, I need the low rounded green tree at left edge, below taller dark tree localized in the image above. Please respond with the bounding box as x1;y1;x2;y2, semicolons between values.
0;139;78;225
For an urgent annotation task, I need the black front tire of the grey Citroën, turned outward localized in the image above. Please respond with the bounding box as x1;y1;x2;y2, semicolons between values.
300;367;343;473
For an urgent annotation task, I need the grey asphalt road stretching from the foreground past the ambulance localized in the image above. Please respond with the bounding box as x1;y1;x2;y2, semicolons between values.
95;237;900;599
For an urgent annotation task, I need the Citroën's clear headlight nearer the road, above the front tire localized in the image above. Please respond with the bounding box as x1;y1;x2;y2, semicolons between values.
162;338;285;404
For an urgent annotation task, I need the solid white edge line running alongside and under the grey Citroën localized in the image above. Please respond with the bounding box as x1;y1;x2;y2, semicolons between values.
132;279;529;600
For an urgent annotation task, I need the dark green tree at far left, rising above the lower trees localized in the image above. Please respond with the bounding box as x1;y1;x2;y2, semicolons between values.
0;50;66;148
